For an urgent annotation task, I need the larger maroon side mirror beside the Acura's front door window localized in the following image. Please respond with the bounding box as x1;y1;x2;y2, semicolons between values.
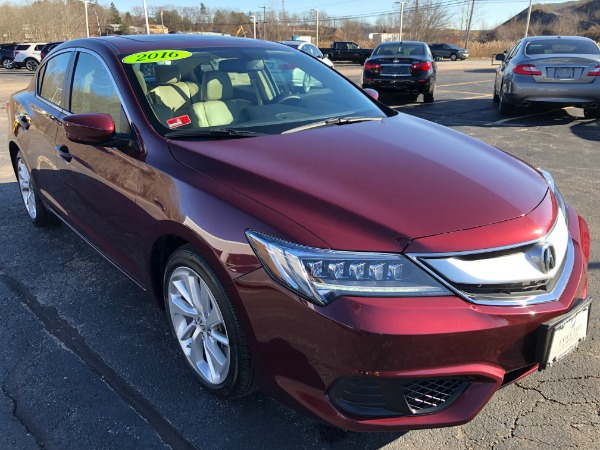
63;113;116;145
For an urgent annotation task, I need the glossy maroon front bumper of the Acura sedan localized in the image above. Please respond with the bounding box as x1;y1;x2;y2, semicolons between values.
229;213;589;431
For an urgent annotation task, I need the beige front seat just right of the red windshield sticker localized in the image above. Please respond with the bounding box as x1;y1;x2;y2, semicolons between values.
192;71;250;127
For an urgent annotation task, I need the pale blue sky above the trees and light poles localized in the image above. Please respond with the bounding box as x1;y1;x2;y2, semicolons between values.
99;0;564;29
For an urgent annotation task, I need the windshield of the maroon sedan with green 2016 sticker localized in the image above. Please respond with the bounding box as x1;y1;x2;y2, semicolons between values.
121;45;395;139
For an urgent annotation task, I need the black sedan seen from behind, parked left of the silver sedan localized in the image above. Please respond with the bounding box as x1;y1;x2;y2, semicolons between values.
361;41;436;103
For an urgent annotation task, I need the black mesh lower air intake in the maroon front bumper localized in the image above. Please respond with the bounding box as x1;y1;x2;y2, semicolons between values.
329;377;469;417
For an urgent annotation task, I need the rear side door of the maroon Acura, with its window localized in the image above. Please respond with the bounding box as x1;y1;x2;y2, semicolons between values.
19;52;72;209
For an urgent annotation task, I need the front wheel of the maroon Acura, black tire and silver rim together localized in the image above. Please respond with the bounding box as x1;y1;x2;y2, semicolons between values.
164;245;254;398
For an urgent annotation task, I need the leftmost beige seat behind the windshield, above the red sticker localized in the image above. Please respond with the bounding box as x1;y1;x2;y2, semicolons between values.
148;65;200;123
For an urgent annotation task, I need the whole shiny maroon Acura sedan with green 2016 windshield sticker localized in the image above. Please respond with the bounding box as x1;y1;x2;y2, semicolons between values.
7;35;591;431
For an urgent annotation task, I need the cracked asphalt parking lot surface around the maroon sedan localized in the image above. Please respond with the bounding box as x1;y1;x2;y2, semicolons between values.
0;60;600;450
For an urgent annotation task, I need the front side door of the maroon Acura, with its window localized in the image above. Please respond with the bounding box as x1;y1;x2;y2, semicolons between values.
56;51;143;279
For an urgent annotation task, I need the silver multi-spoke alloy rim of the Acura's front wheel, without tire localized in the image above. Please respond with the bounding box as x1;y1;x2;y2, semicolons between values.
167;266;231;387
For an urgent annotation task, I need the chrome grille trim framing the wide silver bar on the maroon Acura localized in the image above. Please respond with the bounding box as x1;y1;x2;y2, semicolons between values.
406;214;575;306
